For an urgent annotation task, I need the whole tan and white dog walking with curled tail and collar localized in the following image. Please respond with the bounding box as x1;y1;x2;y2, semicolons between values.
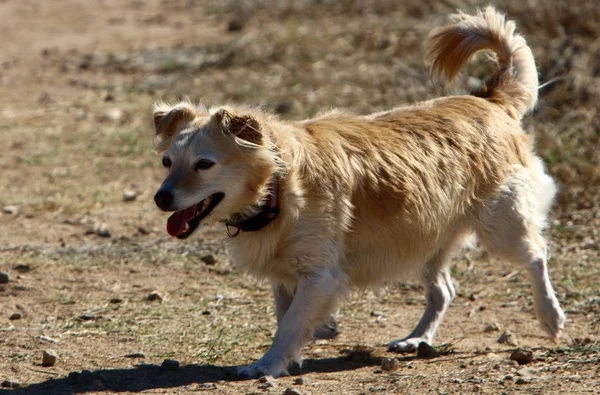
154;7;565;377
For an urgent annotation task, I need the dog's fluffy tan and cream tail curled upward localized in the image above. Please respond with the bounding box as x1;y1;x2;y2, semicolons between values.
426;6;538;119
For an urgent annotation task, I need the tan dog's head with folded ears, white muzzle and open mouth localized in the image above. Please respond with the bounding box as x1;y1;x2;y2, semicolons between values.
154;103;277;239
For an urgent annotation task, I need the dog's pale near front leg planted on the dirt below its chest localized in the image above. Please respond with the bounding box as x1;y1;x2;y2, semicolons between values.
239;262;346;377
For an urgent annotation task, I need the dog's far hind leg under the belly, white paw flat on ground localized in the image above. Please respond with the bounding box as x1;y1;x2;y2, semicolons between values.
387;248;456;352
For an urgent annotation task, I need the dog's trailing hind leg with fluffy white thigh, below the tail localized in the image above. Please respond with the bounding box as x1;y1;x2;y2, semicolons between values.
476;163;565;339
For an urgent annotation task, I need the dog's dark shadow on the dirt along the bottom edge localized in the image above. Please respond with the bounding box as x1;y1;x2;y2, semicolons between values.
9;356;398;395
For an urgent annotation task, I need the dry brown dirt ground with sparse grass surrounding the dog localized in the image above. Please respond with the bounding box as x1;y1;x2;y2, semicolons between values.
0;0;600;394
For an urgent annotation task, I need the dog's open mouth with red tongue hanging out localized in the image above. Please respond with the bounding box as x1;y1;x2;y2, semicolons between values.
167;192;225;239
